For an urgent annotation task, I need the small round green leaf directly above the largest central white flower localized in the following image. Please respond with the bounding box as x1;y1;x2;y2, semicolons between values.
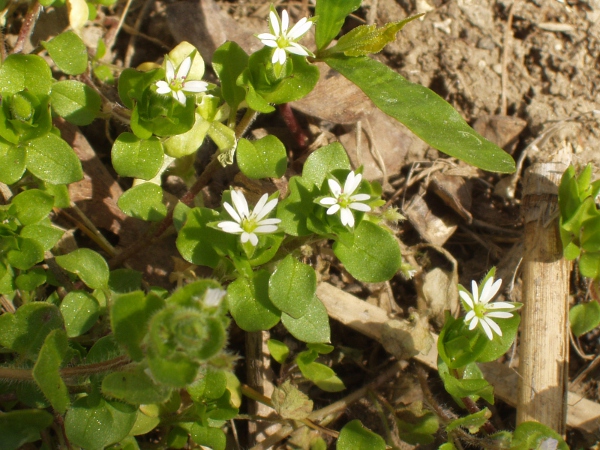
236;134;287;179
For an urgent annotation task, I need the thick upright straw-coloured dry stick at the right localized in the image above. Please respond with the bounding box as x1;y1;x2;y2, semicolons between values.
517;162;570;435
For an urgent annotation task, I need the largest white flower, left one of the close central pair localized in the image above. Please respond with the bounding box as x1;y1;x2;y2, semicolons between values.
217;191;281;247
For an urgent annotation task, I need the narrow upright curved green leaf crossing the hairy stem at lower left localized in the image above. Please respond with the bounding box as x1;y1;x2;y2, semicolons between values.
33;330;71;414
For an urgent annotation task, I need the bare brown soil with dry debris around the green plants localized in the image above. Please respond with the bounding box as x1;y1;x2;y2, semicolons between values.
14;0;600;448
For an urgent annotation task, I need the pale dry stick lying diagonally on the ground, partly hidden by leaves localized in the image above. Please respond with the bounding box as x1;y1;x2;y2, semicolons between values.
317;283;600;433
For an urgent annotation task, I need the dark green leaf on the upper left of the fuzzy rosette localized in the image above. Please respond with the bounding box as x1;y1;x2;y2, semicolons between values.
110;291;165;361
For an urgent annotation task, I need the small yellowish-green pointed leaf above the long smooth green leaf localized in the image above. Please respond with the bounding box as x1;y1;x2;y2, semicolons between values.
318;14;422;58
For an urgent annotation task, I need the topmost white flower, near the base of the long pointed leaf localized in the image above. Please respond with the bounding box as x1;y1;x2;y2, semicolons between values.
256;9;314;64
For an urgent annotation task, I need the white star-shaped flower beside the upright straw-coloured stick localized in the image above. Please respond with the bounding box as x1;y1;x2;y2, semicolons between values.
459;277;519;340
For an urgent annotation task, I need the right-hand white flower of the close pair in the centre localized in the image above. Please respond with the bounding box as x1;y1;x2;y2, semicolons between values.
319;172;371;227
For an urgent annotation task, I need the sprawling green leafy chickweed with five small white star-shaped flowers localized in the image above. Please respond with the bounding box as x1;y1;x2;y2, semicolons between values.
0;0;568;450
